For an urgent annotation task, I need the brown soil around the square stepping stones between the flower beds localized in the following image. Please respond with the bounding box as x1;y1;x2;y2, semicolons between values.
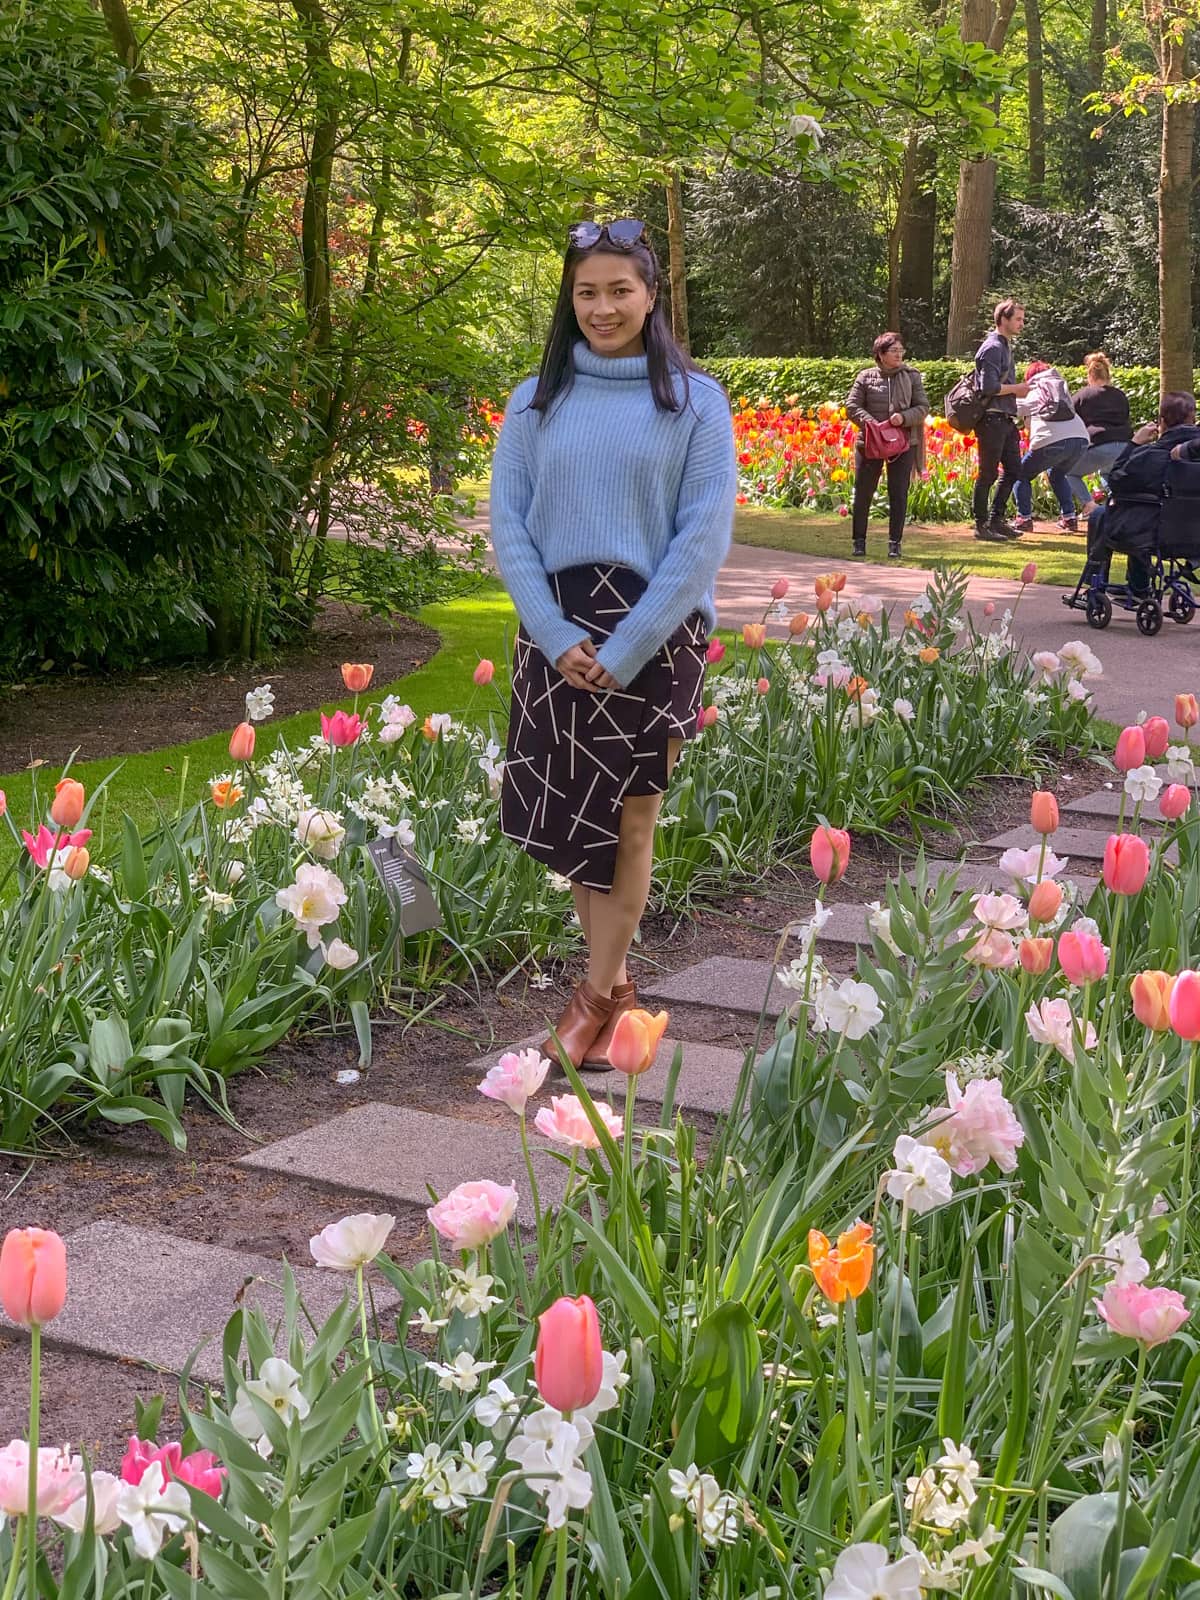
0;748;1110;1469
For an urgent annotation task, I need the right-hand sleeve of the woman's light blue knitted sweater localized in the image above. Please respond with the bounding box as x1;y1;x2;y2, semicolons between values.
597;390;738;688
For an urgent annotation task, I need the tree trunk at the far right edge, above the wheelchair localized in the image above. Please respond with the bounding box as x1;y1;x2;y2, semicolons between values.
1158;6;1195;394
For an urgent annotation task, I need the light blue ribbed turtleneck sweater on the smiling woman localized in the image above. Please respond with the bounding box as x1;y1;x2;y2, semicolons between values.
491;339;738;686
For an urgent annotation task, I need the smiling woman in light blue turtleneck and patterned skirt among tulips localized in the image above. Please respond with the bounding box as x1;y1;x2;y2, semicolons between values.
491;218;738;1070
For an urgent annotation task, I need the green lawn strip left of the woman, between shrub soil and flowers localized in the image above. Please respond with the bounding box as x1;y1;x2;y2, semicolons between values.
0;579;515;862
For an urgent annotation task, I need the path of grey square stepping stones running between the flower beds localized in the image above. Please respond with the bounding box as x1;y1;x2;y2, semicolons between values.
0;771;1150;1382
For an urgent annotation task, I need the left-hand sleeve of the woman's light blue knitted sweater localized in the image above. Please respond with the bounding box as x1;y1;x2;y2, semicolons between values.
488;386;589;664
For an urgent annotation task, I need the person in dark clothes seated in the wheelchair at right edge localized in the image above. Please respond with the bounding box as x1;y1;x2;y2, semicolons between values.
1085;392;1200;598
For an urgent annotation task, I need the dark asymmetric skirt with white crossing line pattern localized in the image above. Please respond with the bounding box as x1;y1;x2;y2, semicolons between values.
501;565;709;890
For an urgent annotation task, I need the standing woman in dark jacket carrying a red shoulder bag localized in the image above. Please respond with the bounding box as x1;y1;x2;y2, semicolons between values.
846;333;930;562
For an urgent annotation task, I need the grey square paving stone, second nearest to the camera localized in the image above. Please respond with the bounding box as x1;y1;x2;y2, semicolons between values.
240;1101;566;1203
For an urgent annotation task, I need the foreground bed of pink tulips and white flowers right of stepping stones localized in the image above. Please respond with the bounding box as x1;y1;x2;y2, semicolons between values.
0;713;1200;1600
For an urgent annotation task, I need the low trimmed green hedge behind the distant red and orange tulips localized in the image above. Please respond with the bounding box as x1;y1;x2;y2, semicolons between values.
702;355;1200;424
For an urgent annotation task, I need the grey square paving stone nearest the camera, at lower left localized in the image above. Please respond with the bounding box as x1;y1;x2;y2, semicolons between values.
25;1200;398;1382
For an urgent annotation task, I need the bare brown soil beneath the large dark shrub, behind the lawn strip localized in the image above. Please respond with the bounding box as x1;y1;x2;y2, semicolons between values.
0;602;438;773
